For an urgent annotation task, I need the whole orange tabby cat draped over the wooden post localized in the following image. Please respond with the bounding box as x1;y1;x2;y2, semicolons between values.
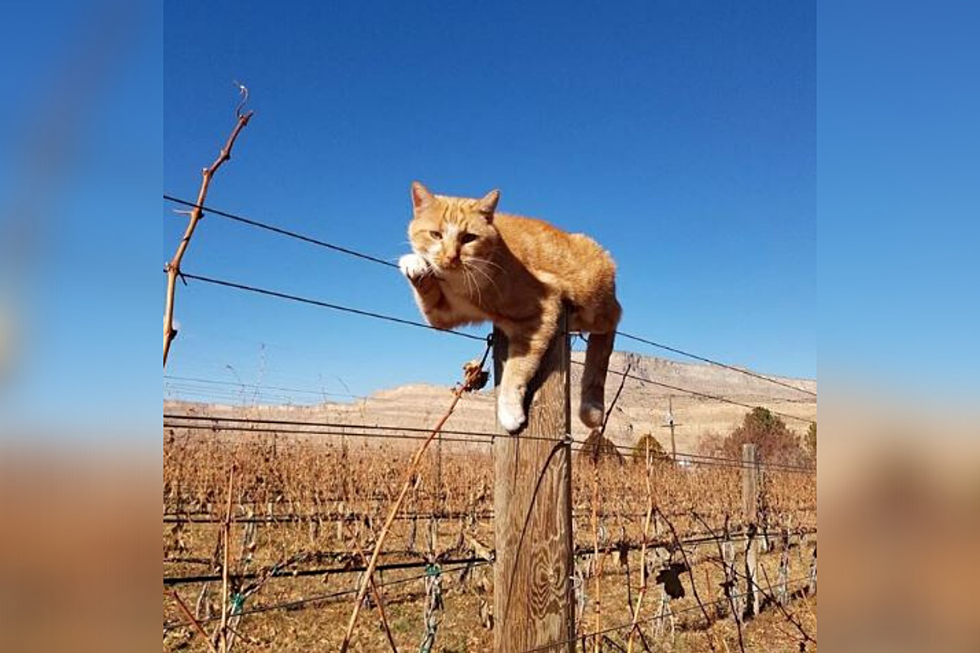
399;182;622;433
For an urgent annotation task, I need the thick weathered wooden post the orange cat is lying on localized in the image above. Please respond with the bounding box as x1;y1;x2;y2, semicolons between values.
493;309;575;653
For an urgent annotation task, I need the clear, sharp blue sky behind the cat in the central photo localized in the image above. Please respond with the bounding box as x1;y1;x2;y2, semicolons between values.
165;1;817;399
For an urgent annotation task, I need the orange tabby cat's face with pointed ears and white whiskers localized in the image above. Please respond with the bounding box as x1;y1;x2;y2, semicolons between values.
408;181;500;272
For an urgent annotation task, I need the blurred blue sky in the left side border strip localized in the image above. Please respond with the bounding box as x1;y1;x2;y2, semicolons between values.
0;0;163;432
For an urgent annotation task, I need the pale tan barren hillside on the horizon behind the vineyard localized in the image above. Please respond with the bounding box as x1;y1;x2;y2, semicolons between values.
164;352;817;451
